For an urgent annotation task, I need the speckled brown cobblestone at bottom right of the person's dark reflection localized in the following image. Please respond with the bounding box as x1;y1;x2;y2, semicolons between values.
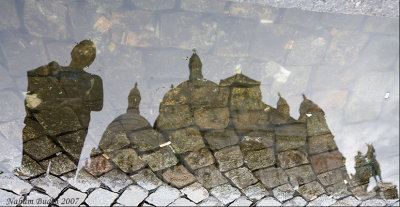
39;154;76;175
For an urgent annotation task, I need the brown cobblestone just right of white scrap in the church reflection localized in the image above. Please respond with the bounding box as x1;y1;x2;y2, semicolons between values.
169;127;205;154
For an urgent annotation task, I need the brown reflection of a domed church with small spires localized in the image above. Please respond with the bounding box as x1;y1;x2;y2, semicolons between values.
86;53;398;204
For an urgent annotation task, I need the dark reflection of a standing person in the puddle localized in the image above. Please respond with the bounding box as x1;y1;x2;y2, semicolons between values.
19;40;103;176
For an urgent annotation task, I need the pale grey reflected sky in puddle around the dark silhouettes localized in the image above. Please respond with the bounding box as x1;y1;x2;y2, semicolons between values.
0;1;399;204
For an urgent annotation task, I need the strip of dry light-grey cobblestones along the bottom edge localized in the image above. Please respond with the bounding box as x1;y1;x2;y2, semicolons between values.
0;170;399;206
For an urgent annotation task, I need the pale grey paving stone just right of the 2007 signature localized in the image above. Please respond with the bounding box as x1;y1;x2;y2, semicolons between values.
85;188;118;206
